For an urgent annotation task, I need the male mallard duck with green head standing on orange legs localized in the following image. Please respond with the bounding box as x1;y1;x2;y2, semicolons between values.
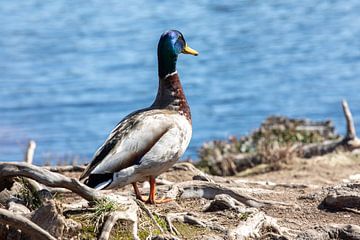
80;30;198;204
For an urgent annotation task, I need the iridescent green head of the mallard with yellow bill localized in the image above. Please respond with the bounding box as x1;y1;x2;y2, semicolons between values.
158;30;199;78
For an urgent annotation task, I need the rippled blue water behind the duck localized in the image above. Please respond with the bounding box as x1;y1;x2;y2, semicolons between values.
0;0;360;163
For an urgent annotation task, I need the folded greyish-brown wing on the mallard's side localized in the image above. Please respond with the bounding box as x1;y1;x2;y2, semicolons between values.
80;110;172;179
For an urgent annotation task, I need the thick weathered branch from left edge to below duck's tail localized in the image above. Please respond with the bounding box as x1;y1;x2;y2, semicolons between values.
0;162;104;201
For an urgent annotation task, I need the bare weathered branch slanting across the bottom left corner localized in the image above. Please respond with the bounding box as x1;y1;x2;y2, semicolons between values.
0;208;56;240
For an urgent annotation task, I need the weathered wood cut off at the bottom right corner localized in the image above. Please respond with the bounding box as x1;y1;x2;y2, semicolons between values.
296;224;360;240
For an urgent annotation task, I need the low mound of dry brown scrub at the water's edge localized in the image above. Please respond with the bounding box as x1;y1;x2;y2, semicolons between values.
196;116;339;176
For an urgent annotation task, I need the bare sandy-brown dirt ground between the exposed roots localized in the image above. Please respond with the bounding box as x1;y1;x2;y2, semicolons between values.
58;153;360;239
